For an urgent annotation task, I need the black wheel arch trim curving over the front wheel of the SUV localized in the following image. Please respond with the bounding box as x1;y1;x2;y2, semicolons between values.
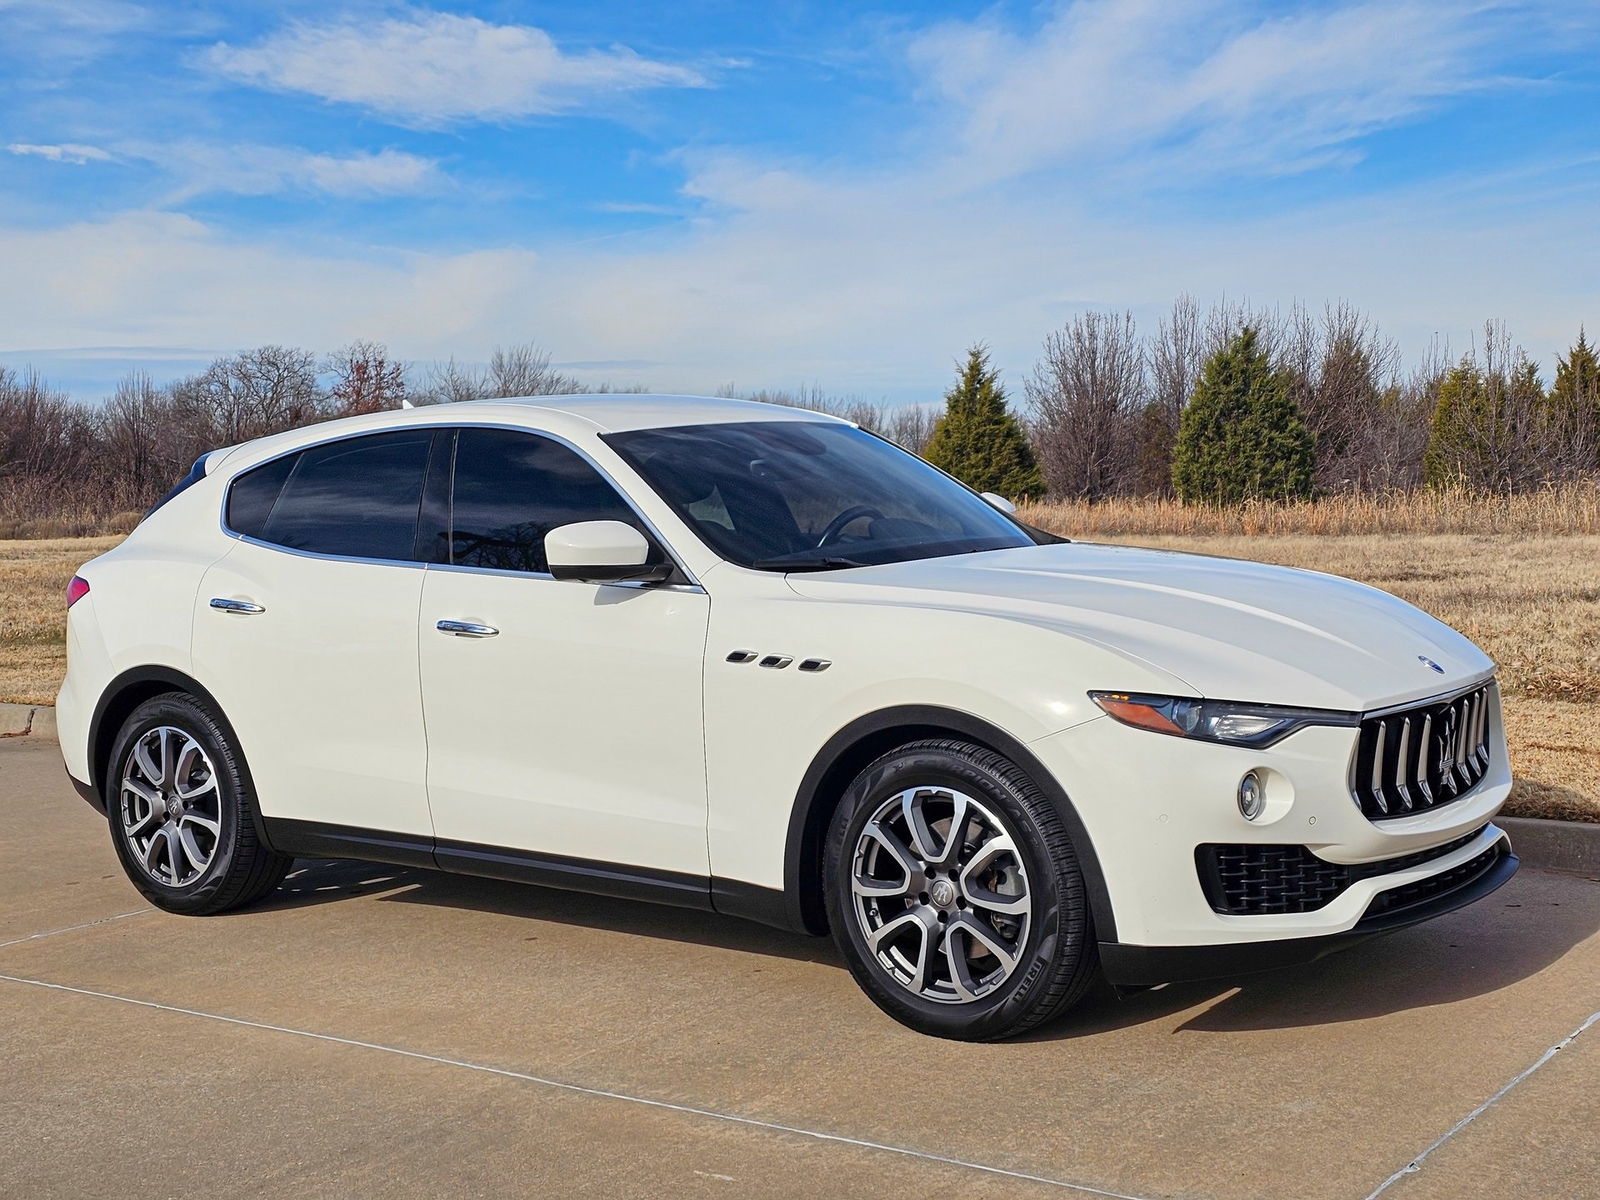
780;704;1117;942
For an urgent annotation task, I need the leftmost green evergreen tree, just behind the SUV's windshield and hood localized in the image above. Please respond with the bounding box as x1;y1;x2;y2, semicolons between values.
923;346;1045;499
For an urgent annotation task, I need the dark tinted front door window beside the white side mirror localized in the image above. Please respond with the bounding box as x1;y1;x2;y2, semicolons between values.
450;429;661;571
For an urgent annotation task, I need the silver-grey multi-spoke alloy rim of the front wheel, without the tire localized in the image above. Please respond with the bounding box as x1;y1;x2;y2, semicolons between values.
851;787;1034;1005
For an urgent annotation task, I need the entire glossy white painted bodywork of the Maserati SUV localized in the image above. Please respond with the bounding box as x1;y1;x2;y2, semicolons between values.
59;397;1510;946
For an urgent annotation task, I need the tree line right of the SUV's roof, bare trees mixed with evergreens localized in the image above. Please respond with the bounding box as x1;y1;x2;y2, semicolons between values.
925;298;1600;504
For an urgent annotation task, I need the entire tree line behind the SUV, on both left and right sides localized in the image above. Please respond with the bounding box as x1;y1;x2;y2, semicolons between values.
0;296;1600;522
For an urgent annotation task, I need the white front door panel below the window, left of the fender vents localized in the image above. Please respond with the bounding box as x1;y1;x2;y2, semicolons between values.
418;568;710;875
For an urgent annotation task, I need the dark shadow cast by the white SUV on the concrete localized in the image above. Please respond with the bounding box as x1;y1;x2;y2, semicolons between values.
259;861;1600;1042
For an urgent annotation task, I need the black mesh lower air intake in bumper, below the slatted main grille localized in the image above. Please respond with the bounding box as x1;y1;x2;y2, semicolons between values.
1195;826;1484;917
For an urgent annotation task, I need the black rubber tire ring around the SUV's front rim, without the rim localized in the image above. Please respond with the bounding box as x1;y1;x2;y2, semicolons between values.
824;747;1064;1042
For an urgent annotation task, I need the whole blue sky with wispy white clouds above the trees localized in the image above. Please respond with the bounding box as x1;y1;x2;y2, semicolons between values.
0;0;1600;400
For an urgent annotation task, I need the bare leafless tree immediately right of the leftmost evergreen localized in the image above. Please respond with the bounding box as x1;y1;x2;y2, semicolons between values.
1026;312;1147;501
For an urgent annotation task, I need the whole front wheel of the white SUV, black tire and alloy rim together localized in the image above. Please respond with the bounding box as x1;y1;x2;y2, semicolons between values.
822;741;1099;1042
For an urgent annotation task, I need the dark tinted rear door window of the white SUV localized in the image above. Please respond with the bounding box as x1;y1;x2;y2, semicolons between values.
248;430;434;560
